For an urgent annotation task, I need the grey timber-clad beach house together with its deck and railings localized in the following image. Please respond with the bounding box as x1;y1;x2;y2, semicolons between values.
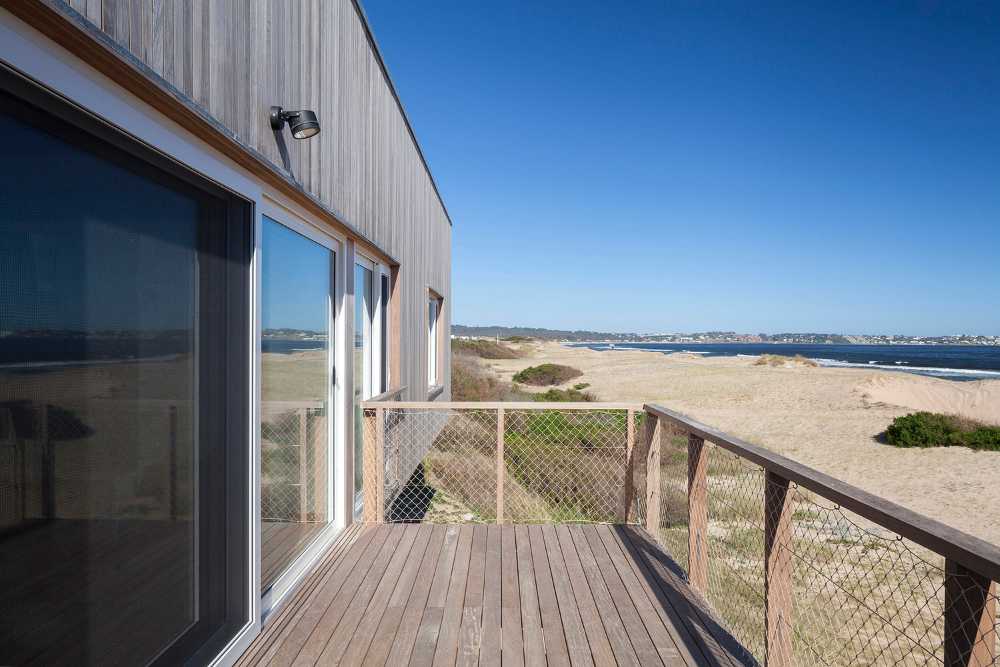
0;0;1000;667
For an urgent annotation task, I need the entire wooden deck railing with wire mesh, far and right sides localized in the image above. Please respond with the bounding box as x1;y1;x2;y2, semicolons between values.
364;400;1000;667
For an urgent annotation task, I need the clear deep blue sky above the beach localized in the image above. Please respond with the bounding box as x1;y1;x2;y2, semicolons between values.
364;0;1000;335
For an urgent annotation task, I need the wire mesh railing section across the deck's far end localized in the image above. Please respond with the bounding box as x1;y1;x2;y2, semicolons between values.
364;403;641;523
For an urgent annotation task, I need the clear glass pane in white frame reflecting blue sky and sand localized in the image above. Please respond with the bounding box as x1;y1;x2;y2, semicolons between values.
260;217;336;592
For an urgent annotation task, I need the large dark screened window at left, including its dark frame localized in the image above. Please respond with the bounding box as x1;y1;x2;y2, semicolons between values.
0;69;252;665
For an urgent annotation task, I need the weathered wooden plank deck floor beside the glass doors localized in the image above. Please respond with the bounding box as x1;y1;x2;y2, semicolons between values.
239;524;747;666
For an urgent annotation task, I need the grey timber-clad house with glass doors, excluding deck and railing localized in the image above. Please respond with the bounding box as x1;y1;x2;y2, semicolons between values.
0;0;452;664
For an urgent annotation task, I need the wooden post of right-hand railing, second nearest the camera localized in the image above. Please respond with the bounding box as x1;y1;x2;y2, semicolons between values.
764;472;792;667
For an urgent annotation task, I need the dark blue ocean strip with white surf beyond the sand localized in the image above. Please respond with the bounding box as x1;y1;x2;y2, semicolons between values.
568;343;1000;380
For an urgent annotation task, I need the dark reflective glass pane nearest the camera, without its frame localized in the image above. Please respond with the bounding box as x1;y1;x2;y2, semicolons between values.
0;95;225;664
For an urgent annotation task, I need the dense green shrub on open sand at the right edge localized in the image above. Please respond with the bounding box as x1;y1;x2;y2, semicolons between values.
885;412;1000;452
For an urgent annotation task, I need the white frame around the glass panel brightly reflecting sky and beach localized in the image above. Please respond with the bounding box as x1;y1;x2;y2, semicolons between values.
251;195;347;623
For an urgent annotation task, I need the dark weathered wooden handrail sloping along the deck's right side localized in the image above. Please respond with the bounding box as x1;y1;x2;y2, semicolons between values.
643;404;1000;581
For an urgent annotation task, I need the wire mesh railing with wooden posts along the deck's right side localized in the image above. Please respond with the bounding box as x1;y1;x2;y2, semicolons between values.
641;406;1000;667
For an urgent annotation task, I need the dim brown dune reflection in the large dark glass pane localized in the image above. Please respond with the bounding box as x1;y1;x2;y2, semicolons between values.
0;359;195;527
